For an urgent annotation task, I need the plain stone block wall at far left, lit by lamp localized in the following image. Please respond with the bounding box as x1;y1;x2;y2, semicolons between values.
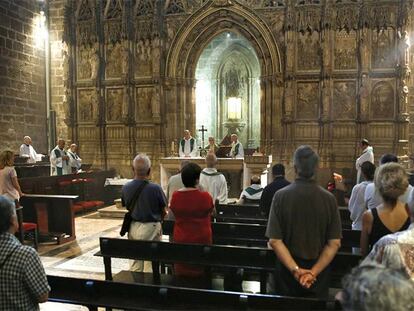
0;0;47;153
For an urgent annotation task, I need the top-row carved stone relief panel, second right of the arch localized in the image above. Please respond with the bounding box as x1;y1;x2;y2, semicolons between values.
334;30;357;70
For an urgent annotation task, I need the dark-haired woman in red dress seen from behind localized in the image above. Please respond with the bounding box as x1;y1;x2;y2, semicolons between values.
170;163;214;277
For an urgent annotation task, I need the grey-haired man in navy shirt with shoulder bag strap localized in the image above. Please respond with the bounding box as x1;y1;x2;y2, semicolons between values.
122;154;167;272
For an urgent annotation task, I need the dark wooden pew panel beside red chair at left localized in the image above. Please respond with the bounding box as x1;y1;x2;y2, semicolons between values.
20;194;78;244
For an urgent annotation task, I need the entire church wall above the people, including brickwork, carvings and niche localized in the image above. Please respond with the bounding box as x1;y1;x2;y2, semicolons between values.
0;0;414;179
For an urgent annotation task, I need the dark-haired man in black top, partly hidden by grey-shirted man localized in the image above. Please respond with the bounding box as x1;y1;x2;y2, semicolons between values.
260;164;290;217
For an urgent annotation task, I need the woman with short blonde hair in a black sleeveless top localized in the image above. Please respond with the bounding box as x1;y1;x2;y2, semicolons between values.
361;163;410;257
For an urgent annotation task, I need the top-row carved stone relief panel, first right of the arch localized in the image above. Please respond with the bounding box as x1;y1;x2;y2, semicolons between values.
297;31;321;71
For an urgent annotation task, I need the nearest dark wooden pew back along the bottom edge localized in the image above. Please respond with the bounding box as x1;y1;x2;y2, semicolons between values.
48;275;340;311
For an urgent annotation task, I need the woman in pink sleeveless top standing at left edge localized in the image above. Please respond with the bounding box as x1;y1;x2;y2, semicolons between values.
0;151;23;201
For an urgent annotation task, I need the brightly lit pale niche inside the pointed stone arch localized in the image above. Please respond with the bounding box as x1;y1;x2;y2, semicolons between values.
195;31;260;148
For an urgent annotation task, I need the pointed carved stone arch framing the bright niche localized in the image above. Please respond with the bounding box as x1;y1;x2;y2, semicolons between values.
163;1;284;154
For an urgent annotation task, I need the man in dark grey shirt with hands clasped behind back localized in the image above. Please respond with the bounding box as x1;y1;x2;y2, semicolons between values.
266;146;342;299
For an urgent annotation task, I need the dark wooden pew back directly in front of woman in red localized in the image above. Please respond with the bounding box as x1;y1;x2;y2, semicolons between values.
162;220;361;249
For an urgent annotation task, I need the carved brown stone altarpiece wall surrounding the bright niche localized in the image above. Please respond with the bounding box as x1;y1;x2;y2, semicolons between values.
62;0;414;179
